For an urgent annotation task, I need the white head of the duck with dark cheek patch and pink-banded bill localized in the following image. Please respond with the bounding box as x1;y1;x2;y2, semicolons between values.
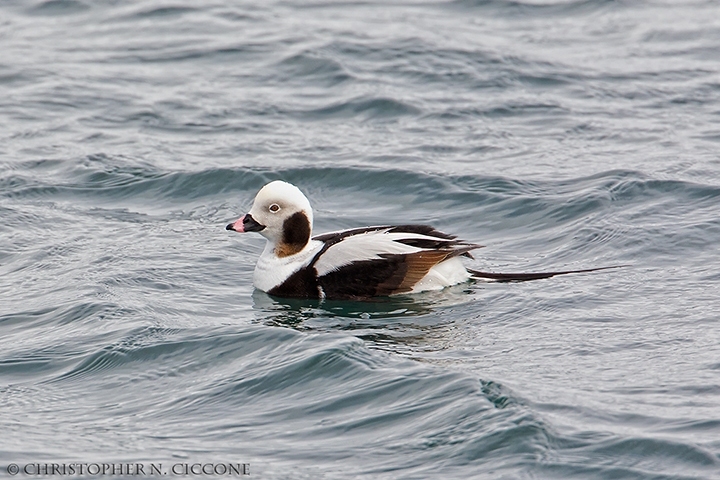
226;180;313;257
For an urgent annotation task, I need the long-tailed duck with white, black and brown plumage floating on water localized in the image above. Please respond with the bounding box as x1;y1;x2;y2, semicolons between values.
226;180;612;300
